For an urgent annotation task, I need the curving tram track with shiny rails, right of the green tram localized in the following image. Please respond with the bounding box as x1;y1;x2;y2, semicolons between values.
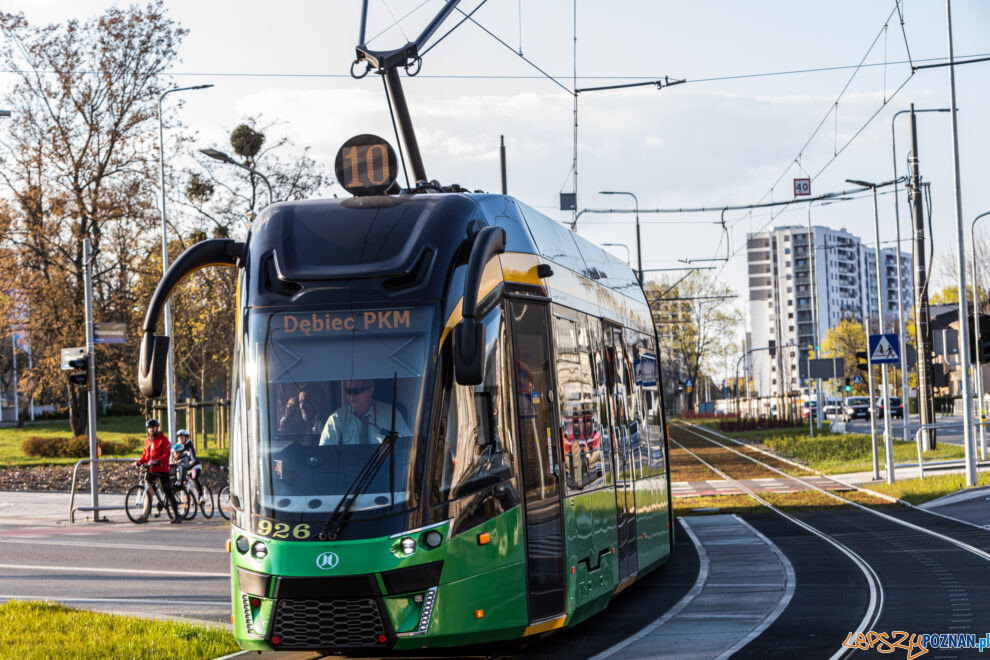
671;424;990;657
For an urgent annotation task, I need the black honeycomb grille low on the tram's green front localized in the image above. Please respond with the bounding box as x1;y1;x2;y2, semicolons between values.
271;598;385;649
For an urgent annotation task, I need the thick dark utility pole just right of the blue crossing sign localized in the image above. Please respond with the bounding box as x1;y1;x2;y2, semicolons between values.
905;103;936;451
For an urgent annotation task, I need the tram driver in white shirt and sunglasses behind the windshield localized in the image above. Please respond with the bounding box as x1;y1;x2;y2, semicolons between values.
320;379;412;445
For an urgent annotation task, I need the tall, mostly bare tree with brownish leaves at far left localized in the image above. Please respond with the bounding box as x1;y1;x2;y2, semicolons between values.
0;5;186;434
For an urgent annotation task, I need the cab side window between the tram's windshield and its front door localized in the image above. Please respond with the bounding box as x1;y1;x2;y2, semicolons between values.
433;307;515;502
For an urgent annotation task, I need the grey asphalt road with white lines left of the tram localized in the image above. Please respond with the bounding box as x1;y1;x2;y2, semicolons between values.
0;520;230;624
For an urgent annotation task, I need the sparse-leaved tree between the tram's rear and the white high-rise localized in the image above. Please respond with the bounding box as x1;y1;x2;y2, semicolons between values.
645;271;742;409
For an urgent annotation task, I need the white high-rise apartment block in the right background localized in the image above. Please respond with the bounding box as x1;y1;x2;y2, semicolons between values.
747;225;914;396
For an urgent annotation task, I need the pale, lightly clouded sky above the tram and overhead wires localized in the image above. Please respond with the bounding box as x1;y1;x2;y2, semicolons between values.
0;0;990;372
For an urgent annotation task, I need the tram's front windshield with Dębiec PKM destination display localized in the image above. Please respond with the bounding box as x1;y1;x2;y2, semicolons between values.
244;308;435;522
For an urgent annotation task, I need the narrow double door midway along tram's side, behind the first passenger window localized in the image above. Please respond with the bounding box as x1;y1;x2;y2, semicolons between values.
602;325;638;582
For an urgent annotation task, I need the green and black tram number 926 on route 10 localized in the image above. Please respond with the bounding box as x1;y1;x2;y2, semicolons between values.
138;3;673;653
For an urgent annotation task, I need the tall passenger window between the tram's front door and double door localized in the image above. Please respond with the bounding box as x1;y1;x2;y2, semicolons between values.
554;310;606;494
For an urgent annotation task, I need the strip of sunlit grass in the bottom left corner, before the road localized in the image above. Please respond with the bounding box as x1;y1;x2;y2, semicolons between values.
0;600;238;660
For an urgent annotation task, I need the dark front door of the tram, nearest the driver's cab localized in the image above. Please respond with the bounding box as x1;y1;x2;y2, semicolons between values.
509;300;566;623
